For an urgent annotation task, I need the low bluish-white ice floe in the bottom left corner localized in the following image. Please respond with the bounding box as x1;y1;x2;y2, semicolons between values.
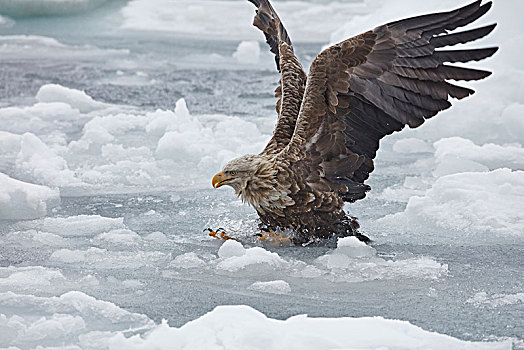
0;291;154;349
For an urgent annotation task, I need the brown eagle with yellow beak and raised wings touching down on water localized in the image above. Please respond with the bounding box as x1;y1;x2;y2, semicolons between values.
212;0;497;242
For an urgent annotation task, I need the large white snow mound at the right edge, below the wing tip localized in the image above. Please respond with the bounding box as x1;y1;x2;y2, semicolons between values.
379;169;524;239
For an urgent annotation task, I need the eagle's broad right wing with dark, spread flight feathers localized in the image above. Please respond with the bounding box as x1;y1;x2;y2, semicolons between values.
279;1;497;202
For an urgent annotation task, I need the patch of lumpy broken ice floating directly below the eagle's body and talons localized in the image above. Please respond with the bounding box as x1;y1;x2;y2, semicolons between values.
194;237;448;284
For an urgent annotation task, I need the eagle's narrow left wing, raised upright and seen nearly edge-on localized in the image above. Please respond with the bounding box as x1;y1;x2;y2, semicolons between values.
249;0;307;154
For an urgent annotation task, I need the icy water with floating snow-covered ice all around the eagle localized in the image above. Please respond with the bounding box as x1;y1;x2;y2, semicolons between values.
0;0;524;349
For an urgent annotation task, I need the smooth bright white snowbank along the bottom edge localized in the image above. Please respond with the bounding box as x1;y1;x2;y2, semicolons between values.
110;306;511;350
